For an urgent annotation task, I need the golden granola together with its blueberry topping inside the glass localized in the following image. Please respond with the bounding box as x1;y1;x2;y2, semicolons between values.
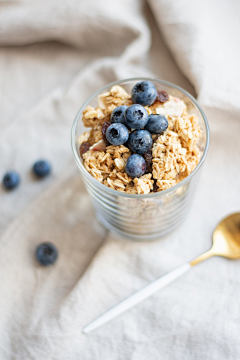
78;81;201;194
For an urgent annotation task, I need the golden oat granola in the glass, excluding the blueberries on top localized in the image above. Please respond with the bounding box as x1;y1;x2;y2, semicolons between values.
78;86;201;194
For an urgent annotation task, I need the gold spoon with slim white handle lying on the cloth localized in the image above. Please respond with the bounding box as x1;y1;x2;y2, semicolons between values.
83;213;240;333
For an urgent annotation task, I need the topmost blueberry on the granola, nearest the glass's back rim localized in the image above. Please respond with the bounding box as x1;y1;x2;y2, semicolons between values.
132;81;157;106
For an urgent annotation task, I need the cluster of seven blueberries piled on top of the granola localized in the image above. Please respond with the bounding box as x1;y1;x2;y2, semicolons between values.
106;81;168;178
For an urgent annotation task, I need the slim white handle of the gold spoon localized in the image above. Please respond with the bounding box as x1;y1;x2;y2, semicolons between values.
82;263;191;334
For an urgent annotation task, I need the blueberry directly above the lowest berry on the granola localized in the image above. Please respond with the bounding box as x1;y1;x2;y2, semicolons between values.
127;130;153;154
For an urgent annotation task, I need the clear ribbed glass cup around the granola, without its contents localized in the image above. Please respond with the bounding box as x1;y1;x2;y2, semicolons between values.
71;78;209;241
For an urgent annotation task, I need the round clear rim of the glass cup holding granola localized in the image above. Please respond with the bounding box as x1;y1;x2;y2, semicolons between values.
71;77;210;199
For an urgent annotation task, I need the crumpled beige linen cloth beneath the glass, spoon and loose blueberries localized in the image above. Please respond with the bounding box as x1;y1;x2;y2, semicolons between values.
0;0;240;360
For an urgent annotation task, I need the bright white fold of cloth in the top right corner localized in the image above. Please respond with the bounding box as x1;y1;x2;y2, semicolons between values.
148;0;240;113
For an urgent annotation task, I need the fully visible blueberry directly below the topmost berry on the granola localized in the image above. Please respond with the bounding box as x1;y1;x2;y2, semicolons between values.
125;104;148;129
